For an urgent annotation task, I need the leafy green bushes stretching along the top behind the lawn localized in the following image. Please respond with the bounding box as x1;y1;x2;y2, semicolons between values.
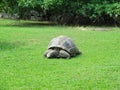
0;0;120;24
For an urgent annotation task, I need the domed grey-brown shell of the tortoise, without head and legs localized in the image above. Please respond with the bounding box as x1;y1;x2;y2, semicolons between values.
48;36;80;56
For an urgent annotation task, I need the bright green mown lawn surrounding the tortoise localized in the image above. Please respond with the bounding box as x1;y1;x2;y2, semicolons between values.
0;19;120;90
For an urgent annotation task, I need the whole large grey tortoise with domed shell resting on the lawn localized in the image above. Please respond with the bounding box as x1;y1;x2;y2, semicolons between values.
44;35;81;59
